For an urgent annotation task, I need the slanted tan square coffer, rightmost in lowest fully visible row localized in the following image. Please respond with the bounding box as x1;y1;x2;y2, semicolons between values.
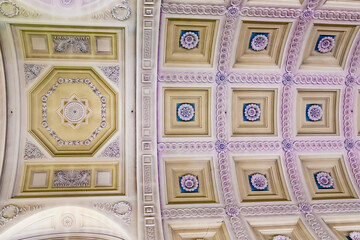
299;155;357;200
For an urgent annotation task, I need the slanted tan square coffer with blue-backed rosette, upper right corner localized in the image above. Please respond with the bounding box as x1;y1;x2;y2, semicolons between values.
300;24;358;70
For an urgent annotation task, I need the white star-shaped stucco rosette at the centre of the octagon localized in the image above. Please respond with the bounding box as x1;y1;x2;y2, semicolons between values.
56;94;92;129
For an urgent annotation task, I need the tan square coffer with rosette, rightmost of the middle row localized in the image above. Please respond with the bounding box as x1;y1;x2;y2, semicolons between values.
296;89;340;136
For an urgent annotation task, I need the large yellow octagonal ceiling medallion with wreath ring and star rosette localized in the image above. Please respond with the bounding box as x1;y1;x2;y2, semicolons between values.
28;67;118;157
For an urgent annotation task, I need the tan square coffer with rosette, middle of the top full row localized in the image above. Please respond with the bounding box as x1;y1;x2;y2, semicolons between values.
233;21;291;68
